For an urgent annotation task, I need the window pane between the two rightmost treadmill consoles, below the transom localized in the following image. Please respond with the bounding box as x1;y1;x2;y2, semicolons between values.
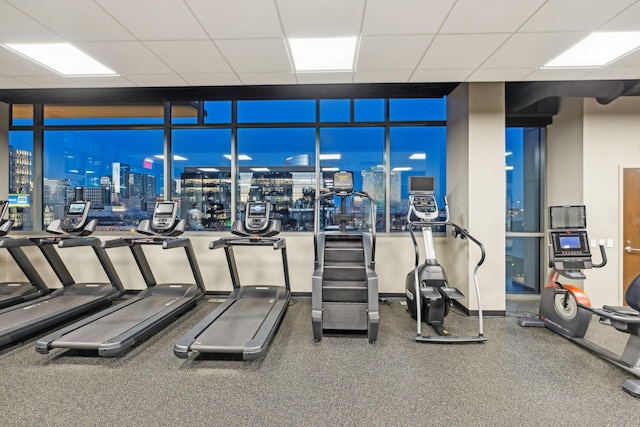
172;129;231;230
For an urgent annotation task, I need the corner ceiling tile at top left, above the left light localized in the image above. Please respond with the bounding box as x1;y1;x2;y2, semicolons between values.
0;2;63;43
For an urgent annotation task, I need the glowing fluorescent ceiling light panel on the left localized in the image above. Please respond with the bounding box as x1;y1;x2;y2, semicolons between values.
4;43;117;76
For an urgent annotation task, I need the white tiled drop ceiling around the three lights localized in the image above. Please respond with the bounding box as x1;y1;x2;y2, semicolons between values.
0;0;640;90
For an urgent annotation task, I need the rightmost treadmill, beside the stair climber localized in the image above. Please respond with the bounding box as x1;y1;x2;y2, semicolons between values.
173;201;291;360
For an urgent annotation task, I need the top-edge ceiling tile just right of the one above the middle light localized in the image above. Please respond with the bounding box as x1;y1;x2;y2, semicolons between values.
362;0;454;35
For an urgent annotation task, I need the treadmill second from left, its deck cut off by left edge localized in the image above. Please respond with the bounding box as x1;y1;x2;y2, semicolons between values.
0;201;124;346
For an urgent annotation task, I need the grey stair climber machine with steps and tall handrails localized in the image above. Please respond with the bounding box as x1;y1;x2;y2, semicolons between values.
311;171;380;343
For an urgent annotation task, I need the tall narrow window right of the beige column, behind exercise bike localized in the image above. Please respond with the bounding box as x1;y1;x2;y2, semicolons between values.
505;128;545;294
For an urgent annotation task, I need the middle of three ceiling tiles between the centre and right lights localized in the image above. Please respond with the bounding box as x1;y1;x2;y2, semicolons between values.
418;34;509;69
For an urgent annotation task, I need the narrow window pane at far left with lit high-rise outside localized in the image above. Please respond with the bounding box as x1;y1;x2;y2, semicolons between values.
9;131;33;230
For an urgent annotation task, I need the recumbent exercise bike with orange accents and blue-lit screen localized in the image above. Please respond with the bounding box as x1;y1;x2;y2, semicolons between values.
518;205;640;397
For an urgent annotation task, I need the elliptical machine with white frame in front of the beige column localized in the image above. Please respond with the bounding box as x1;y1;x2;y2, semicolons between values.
405;176;487;343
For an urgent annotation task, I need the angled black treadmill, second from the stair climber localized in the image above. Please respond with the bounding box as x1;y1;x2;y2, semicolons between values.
36;201;205;357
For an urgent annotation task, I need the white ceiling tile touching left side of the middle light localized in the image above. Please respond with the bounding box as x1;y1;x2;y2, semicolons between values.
216;39;292;72
